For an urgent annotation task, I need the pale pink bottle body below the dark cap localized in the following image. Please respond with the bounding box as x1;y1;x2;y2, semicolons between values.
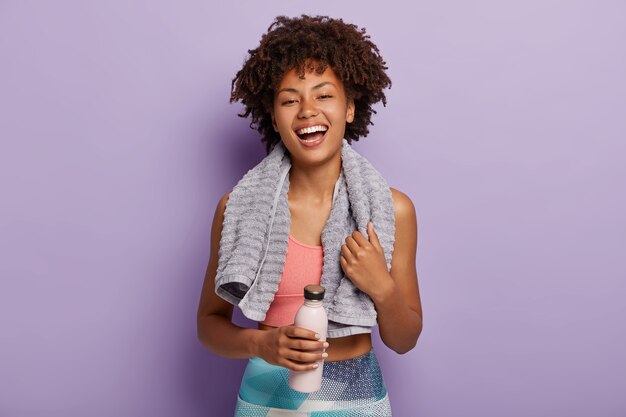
289;300;328;392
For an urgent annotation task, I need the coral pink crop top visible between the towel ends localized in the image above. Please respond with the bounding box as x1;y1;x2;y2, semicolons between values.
261;235;324;327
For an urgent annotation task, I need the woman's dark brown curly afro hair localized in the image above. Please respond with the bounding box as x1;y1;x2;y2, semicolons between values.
230;15;391;153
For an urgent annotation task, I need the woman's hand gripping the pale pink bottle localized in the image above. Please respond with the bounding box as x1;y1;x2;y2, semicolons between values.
258;325;328;371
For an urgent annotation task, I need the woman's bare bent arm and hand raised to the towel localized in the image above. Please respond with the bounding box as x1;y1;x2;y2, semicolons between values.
341;188;422;353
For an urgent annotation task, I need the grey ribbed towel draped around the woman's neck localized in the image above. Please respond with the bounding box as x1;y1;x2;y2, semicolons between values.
215;139;395;337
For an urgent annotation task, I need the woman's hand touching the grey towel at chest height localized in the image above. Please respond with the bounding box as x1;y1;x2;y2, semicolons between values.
340;222;392;296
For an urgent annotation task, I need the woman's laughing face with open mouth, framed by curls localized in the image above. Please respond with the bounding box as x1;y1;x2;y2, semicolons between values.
272;67;354;164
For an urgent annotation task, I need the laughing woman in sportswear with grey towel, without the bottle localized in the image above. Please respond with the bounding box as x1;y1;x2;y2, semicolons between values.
198;15;422;416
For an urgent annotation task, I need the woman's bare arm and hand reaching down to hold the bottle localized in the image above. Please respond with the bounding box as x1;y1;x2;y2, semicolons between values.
197;194;324;371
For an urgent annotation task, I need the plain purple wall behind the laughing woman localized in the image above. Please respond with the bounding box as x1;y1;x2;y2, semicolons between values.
0;0;626;417
